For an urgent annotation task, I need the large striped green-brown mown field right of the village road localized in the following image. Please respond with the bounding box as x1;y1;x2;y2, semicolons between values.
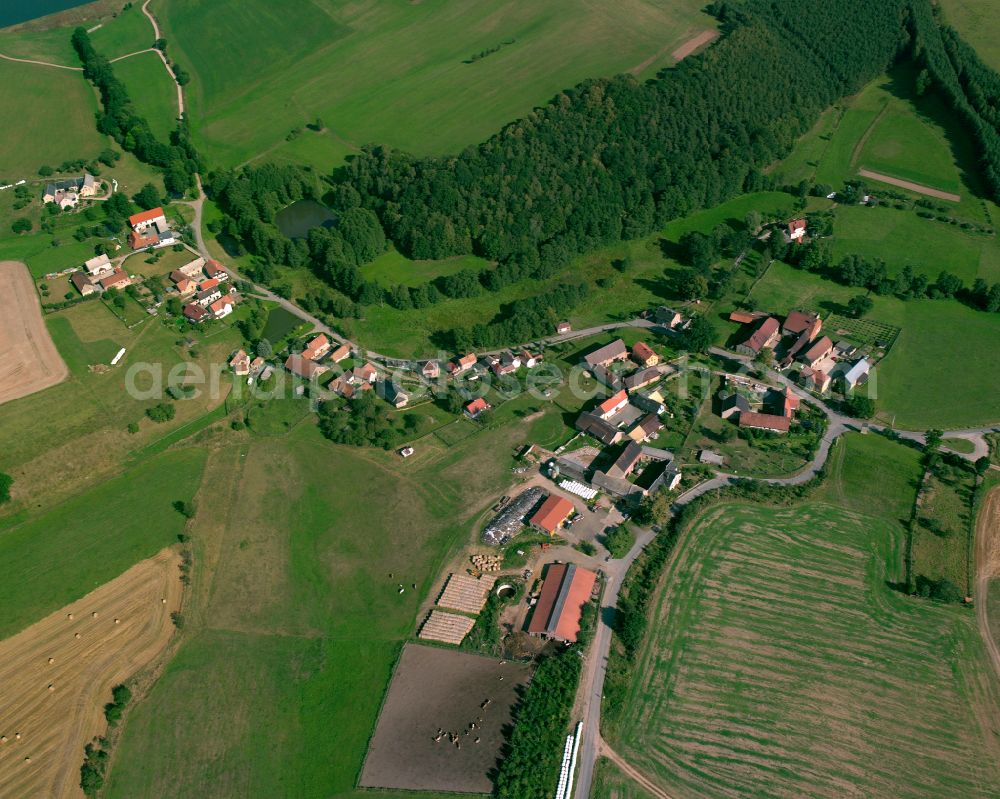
612;436;1000;797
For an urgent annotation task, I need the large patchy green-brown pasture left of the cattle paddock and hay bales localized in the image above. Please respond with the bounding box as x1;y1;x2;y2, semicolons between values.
107;400;556;797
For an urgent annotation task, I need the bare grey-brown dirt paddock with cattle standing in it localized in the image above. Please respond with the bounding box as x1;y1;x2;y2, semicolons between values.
360;644;532;793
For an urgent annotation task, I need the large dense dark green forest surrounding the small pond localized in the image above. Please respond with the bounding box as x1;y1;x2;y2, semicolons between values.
209;0;1000;349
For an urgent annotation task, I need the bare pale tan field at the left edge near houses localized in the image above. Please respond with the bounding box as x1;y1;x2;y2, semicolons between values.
0;261;69;403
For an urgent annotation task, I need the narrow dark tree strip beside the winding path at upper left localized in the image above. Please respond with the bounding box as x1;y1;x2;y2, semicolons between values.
72;28;201;195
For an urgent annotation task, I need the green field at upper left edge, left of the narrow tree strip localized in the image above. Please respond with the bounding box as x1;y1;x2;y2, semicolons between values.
0;61;107;177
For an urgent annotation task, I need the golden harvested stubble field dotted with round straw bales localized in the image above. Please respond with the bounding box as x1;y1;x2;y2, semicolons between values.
0;549;181;799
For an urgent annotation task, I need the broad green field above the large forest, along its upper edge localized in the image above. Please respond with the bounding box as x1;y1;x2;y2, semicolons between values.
158;0;714;168
